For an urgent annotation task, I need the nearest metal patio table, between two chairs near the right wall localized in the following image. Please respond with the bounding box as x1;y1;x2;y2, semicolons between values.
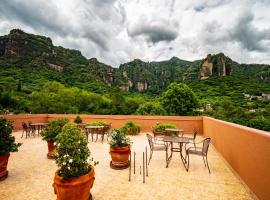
163;136;189;168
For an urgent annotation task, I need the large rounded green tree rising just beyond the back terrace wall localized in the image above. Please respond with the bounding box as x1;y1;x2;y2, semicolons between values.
161;83;198;115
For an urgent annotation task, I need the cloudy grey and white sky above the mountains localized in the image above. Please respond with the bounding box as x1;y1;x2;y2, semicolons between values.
0;0;270;67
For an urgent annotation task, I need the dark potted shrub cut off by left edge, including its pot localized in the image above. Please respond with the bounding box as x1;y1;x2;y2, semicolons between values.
0;118;21;181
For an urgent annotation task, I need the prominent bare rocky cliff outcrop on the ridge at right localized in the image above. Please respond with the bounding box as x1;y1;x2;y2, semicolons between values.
200;53;233;80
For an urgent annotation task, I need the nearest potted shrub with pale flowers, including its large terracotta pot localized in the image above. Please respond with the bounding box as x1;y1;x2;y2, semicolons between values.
53;123;97;200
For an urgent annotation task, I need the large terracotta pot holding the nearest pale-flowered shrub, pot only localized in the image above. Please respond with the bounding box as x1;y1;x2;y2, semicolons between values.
53;165;95;200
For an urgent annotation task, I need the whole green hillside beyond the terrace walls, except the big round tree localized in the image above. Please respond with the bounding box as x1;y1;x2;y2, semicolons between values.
0;29;270;130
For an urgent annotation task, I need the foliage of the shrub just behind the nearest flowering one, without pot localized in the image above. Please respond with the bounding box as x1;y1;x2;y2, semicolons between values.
40;118;69;141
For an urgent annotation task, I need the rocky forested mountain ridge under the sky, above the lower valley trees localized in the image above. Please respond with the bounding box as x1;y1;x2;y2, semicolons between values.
0;29;270;94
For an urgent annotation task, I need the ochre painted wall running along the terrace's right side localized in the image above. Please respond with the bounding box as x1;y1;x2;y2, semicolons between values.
203;117;270;200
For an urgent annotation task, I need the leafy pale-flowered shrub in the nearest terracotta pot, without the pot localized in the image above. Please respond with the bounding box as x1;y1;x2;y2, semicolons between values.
56;123;97;179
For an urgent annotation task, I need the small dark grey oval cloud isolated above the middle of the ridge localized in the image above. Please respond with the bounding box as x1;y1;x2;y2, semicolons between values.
128;24;178;43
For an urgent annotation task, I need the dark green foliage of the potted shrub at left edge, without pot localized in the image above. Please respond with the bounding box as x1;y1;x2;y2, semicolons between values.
0;117;22;155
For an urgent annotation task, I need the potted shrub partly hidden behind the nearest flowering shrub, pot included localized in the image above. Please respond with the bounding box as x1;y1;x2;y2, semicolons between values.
40;118;69;159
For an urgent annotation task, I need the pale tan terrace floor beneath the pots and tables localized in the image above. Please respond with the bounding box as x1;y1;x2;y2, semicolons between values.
0;132;252;200
